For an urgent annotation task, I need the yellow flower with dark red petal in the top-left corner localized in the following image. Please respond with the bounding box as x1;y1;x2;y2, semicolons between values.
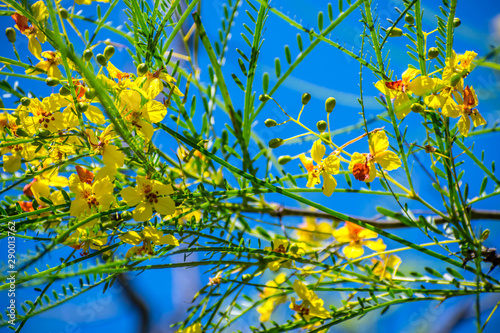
11;0;49;60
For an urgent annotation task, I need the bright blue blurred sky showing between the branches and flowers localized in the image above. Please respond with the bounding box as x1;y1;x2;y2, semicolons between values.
0;0;500;333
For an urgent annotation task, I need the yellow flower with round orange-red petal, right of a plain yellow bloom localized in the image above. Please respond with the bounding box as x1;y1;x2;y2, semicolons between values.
349;131;401;183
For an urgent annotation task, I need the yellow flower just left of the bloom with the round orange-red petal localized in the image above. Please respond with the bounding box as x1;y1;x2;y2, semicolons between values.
299;140;340;197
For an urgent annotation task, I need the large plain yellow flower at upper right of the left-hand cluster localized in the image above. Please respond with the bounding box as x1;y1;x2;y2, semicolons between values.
120;90;167;141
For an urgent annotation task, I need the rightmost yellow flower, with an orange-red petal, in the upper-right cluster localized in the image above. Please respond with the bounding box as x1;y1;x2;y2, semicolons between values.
442;86;486;136
